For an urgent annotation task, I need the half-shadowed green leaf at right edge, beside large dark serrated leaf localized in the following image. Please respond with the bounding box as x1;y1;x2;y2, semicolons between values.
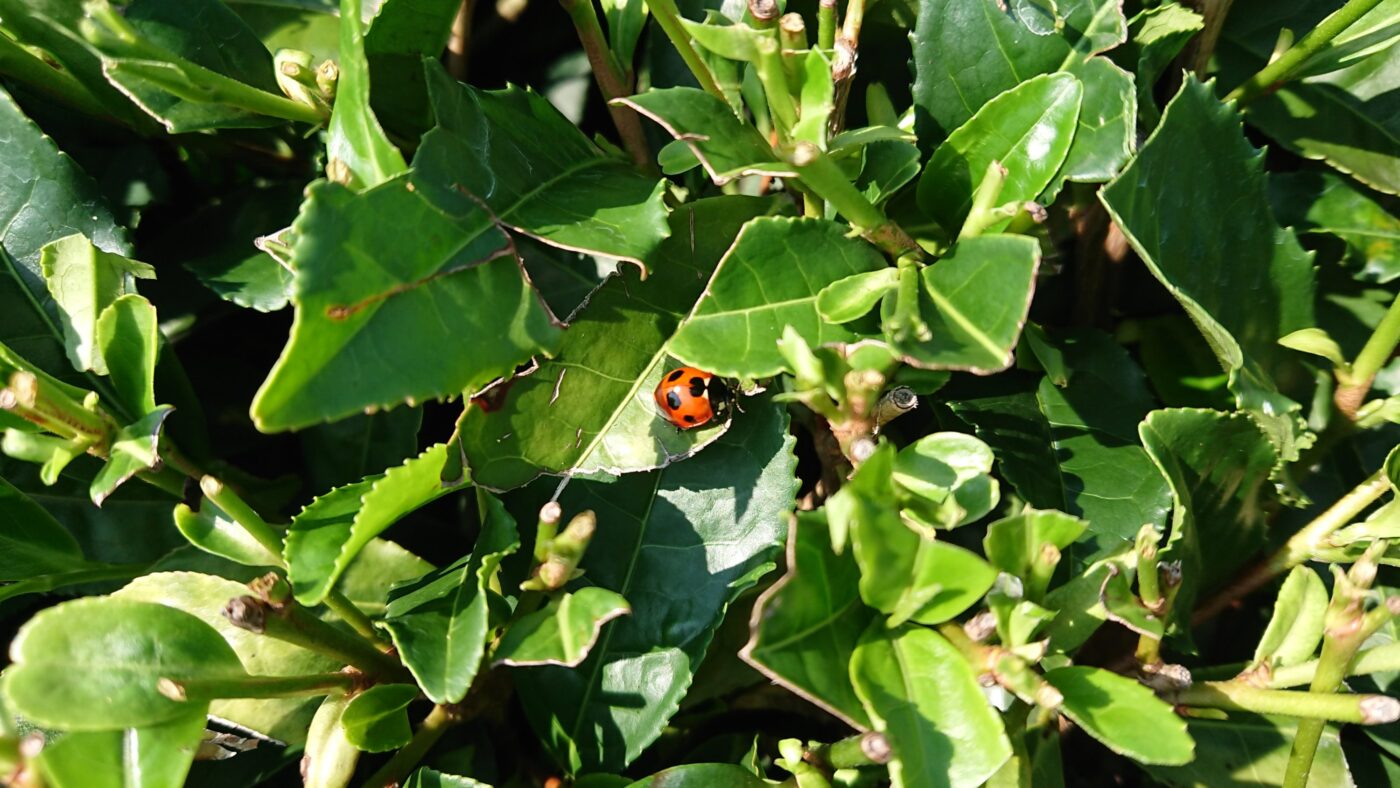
1268;172;1400;284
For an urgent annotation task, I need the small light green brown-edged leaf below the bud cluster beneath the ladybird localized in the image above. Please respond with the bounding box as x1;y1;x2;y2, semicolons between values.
491;586;631;668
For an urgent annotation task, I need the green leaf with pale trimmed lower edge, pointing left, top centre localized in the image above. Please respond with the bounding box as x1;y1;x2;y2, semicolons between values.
615;88;794;186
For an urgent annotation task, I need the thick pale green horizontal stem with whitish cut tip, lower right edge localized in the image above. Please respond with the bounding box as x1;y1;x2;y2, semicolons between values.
1168;682;1400;725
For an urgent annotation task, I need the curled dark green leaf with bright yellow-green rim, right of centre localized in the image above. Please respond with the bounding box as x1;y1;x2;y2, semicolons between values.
1138;409;1277;634
